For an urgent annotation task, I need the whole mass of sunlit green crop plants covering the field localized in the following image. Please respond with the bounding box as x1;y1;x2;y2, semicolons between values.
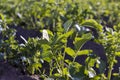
0;0;120;80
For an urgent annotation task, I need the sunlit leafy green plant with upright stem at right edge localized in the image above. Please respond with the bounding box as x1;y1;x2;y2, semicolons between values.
99;28;120;80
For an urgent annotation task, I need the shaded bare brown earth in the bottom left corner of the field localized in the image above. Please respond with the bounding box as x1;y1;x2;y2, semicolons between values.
0;62;40;80
